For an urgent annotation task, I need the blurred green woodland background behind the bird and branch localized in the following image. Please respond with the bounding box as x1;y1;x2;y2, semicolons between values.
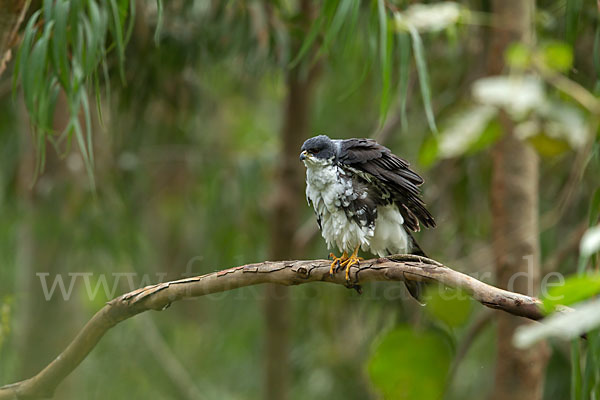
0;0;600;399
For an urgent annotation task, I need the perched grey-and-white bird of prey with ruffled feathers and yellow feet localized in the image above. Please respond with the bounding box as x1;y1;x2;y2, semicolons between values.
300;135;435;299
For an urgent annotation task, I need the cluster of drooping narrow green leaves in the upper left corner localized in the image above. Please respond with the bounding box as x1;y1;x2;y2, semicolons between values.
13;0;162;188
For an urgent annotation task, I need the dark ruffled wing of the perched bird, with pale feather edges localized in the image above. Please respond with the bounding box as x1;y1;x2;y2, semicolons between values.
338;139;435;231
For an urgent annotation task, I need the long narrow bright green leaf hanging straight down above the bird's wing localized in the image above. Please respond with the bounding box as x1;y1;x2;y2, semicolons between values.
377;0;392;126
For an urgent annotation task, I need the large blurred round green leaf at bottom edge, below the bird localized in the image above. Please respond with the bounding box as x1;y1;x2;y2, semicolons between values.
367;325;452;400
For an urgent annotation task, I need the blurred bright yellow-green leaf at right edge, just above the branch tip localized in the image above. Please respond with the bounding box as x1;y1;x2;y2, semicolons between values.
542;275;600;313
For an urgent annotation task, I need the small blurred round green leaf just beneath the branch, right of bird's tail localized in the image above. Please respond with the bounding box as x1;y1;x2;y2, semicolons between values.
425;285;472;327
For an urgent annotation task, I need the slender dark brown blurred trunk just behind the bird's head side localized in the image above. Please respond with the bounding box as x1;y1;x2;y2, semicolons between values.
265;0;318;400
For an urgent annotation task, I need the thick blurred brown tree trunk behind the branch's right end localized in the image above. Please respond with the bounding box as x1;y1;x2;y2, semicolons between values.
488;0;549;400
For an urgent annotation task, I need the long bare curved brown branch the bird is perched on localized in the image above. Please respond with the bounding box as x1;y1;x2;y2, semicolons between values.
0;255;544;400
